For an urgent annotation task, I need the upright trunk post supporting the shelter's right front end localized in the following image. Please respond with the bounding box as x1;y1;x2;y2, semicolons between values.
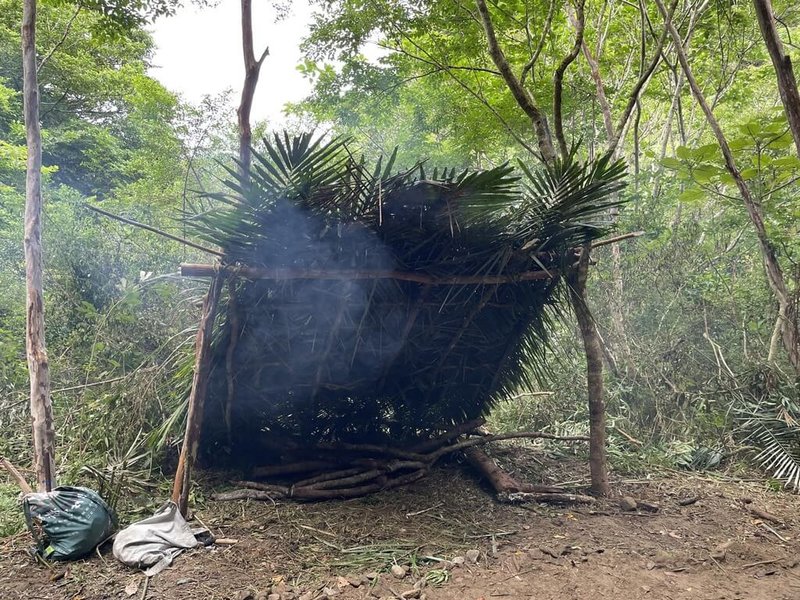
567;244;610;496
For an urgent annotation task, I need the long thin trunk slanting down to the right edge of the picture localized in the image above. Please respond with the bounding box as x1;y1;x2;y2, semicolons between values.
655;0;800;373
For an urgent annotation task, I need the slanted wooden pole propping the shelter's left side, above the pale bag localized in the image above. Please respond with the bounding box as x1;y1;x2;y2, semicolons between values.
172;273;223;516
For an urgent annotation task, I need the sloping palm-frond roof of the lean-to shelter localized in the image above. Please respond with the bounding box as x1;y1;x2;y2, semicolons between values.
187;134;624;452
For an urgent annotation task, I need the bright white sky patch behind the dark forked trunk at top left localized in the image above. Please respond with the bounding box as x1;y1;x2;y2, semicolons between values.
150;0;311;124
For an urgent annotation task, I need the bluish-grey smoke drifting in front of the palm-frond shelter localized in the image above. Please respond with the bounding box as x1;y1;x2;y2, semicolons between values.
218;202;408;433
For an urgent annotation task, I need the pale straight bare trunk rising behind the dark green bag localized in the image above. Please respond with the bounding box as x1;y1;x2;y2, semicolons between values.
22;0;56;492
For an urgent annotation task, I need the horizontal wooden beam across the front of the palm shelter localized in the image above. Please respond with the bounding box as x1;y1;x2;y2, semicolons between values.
181;263;559;285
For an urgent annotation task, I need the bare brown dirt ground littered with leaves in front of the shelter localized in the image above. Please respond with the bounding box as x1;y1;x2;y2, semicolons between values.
0;446;800;600
